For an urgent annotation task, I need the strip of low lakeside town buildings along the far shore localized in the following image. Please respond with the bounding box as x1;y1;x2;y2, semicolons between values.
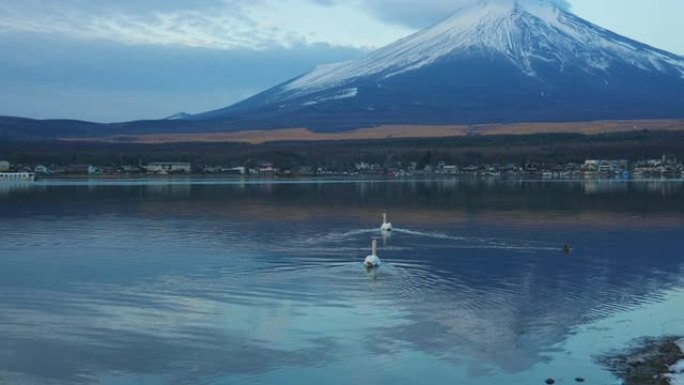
0;155;684;180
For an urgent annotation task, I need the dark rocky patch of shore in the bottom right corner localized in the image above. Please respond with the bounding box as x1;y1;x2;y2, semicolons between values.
598;337;684;385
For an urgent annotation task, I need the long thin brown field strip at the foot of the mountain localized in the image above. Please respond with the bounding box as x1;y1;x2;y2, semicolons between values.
61;120;684;144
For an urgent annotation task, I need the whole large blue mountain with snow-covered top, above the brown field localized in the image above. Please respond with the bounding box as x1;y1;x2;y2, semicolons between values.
190;0;684;131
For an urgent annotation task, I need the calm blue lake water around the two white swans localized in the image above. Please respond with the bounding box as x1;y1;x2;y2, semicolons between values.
0;180;684;385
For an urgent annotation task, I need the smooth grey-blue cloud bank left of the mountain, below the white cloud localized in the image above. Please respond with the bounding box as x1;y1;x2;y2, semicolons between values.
0;33;366;122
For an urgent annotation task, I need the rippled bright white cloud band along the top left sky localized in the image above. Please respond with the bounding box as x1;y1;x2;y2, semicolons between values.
0;0;302;49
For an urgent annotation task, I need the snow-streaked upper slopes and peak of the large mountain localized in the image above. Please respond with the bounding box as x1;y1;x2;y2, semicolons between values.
282;0;684;93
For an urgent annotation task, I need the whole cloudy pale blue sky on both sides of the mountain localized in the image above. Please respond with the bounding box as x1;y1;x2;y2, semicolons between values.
0;0;684;122
